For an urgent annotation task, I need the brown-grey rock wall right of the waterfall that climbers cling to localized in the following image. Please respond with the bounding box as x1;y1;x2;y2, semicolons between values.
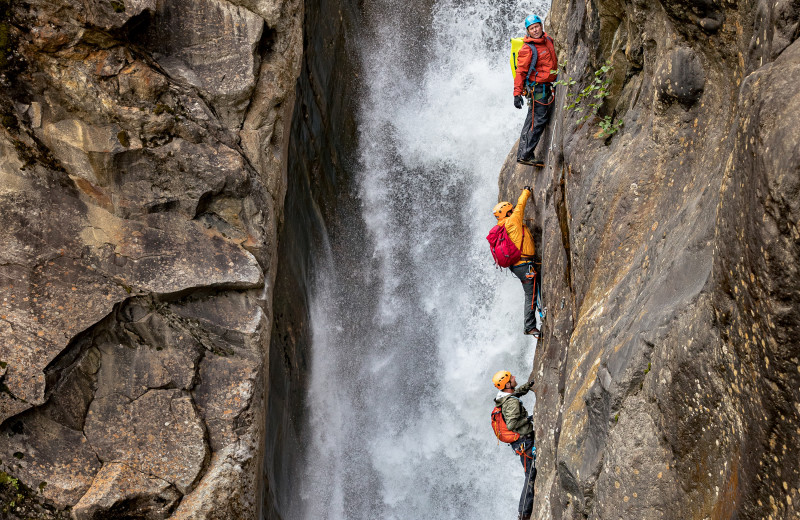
500;0;800;520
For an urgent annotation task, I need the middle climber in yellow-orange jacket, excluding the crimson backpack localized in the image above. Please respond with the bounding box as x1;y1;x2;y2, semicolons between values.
494;186;539;338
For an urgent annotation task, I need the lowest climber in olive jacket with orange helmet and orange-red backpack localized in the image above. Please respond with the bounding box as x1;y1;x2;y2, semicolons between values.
492;370;536;520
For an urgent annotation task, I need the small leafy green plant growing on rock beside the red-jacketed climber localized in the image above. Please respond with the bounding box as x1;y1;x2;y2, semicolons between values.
553;61;623;137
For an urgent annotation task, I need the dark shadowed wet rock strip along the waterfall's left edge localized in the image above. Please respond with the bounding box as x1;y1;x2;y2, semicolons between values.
264;0;363;520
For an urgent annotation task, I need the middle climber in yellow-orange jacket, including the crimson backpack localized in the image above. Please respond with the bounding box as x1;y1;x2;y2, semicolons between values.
486;186;539;338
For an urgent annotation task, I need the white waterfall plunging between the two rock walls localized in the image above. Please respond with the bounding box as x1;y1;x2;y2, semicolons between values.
296;0;547;520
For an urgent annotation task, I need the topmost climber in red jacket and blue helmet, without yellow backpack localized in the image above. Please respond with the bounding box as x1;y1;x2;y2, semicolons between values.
514;15;558;166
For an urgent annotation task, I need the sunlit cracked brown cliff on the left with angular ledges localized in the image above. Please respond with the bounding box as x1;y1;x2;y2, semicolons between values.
0;0;302;519
